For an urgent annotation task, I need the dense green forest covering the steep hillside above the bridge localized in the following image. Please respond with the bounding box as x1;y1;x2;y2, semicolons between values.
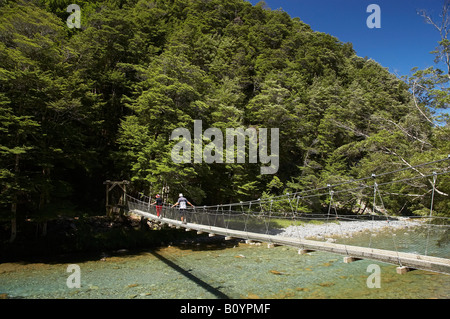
0;0;450;245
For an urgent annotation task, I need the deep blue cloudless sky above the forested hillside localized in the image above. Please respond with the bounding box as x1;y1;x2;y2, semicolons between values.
250;0;444;76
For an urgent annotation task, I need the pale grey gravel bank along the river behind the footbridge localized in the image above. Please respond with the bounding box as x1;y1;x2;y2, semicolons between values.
278;218;421;239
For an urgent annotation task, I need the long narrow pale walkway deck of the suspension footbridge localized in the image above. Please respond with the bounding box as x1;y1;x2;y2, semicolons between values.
130;209;450;274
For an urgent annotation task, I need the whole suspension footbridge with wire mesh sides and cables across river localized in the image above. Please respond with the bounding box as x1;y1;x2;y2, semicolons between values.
127;155;450;274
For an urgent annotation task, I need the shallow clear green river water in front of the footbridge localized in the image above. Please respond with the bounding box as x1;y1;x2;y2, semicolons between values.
0;230;450;299
